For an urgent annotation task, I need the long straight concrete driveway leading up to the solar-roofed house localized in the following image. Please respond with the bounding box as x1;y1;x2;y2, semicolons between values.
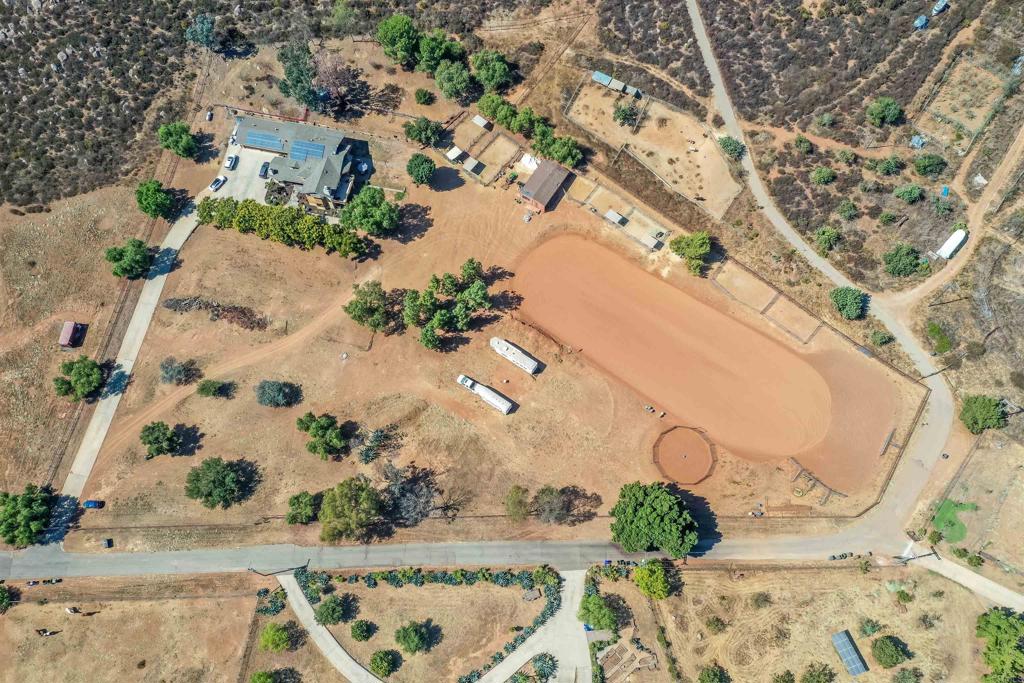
60;210;197;498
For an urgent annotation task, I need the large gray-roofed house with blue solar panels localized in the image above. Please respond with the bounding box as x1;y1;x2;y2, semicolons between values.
234;117;355;211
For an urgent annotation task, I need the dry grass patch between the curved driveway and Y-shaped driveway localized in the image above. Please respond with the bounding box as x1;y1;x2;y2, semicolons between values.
331;584;544;683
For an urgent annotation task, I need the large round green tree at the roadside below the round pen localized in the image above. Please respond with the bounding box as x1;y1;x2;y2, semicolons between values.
611;481;697;557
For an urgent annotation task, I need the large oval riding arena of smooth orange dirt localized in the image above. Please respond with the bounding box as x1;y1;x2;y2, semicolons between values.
515;234;894;484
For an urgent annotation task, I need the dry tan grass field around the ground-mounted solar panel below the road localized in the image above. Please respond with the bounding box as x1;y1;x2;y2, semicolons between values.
647;568;986;683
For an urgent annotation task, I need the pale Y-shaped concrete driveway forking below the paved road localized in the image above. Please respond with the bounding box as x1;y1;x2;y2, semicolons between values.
480;569;591;683
